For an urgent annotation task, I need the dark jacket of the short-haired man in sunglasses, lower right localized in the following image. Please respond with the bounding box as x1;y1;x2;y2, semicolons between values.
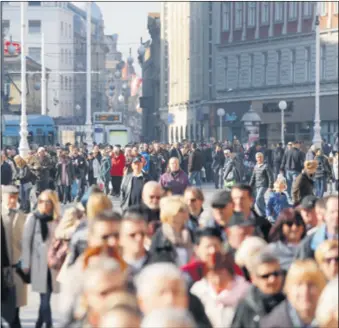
232;286;288;328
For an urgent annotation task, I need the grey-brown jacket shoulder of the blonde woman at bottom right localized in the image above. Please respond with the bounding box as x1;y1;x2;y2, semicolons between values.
260;300;295;328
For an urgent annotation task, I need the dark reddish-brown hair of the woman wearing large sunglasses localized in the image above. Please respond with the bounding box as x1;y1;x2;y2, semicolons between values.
268;208;307;242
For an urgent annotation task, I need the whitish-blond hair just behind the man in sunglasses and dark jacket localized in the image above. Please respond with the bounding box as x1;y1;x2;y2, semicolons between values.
235;236;267;267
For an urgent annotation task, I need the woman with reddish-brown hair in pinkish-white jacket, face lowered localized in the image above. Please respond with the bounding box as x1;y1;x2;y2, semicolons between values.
191;253;250;327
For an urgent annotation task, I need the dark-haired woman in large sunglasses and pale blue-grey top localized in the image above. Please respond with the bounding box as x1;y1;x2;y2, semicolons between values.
268;208;306;272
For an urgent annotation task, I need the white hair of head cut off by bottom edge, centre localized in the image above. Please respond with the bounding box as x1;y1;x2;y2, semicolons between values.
141;308;196;328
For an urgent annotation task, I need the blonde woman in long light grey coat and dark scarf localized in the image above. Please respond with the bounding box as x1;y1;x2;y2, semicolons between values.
22;190;60;328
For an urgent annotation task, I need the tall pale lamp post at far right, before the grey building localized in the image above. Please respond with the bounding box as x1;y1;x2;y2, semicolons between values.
313;2;321;148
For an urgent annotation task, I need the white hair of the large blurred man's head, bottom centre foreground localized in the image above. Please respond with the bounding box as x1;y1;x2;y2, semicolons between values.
134;263;185;297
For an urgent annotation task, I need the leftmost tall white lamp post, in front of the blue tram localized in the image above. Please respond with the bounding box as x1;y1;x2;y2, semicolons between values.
19;1;29;157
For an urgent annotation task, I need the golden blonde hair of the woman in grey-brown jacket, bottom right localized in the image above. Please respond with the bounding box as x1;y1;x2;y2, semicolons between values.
285;260;326;293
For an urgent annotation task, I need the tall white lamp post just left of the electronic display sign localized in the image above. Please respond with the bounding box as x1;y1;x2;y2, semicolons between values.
86;2;93;149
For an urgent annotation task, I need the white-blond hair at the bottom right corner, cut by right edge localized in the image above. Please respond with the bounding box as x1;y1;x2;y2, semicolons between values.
315;278;338;327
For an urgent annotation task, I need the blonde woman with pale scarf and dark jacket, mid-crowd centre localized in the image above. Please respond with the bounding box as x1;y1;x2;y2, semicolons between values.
149;196;193;266
